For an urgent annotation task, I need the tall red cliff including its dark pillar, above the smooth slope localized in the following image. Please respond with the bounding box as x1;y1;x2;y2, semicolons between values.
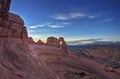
0;0;28;39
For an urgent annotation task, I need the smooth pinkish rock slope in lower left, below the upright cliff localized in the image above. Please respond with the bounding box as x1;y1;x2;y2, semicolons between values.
0;37;55;79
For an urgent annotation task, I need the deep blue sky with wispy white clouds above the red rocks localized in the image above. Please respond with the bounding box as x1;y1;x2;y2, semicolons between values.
10;0;120;43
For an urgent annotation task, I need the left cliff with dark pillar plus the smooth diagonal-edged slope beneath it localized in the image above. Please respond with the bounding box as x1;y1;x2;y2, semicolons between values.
0;0;56;79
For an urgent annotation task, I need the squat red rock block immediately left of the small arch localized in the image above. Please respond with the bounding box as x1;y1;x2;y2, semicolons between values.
46;37;59;47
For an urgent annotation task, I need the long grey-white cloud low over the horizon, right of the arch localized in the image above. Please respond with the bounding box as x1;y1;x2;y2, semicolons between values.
66;38;104;45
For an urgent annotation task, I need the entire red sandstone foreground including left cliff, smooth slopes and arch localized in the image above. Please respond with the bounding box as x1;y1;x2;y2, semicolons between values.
0;0;120;79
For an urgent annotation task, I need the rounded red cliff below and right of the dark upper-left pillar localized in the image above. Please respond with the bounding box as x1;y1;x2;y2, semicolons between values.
0;13;28;39
